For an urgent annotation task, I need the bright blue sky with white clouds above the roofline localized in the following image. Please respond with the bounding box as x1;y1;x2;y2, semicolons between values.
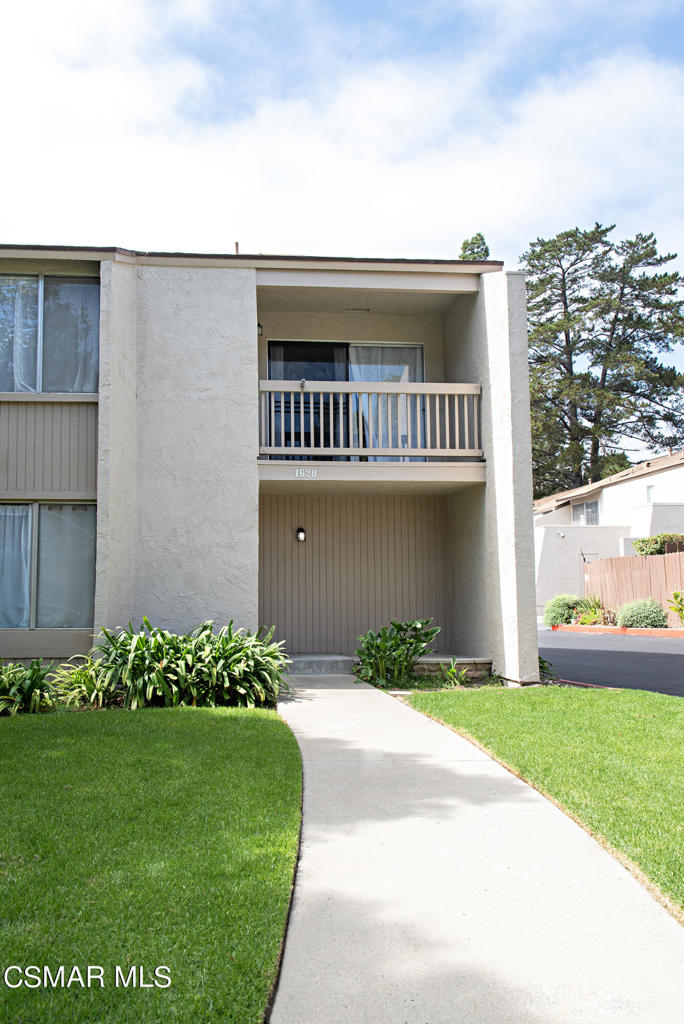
0;0;684;299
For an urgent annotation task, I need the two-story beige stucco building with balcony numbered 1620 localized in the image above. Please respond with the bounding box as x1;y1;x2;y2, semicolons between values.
0;246;538;680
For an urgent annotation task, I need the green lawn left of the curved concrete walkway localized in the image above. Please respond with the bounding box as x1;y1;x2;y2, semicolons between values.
0;709;301;1024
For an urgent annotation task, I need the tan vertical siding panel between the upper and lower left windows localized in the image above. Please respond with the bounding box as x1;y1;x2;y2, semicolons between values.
0;401;97;498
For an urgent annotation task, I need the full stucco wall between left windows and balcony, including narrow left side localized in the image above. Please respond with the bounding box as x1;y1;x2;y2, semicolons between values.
96;263;258;630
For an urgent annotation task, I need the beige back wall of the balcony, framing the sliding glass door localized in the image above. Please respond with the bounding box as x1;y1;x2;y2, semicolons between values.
259;311;444;382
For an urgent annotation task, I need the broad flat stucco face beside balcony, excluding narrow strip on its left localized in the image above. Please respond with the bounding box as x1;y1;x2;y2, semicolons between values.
134;266;259;630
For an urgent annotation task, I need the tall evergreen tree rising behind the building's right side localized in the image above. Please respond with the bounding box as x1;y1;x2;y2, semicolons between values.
521;224;684;496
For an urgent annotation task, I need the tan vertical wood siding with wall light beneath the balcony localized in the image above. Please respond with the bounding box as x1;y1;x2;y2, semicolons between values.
259;495;446;654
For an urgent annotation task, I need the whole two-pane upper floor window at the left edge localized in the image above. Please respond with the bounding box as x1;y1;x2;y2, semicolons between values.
0;274;99;394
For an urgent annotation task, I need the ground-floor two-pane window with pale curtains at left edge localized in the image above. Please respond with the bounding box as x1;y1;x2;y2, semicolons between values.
0;504;95;629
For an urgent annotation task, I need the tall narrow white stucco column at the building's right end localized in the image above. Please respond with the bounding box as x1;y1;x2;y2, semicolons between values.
481;272;539;682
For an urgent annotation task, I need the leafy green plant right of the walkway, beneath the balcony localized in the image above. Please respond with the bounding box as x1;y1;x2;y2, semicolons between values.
353;618;440;687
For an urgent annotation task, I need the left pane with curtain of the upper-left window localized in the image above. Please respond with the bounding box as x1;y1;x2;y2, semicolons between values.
0;274;38;391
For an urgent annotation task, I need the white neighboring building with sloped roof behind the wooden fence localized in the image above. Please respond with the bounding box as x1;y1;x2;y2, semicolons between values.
535;452;684;614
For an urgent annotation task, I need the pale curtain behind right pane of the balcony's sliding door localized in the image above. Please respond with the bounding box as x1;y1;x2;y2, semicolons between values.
349;345;423;462
